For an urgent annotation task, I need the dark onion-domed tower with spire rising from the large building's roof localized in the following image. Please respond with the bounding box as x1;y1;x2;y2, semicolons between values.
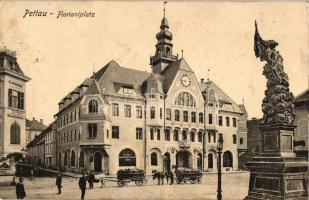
150;8;178;74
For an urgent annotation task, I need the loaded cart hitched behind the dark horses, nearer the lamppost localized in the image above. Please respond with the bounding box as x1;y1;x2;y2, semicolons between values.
176;169;203;184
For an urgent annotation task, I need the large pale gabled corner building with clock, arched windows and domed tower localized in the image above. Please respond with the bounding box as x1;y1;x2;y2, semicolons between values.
55;17;243;174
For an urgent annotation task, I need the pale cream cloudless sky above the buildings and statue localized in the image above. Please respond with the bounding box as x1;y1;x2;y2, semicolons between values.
0;1;309;124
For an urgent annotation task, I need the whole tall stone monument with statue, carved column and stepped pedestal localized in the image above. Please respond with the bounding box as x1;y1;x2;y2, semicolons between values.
245;23;308;200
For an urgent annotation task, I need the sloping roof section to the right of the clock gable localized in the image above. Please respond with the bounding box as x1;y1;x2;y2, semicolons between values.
200;81;243;113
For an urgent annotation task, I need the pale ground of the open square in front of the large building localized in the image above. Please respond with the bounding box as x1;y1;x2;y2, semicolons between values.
0;172;249;200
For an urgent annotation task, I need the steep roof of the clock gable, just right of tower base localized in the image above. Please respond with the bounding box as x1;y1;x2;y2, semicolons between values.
161;58;192;93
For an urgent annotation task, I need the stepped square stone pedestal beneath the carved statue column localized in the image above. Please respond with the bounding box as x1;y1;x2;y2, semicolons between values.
245;124;308;200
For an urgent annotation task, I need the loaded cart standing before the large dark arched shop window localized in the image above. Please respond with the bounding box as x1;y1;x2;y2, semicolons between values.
117;169;146;187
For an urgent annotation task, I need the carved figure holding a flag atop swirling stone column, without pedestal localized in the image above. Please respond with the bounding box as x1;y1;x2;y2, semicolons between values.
254;22;295;125
